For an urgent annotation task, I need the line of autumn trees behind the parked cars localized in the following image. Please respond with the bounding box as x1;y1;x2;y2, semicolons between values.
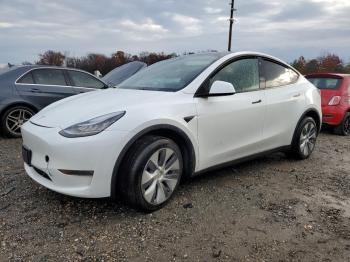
30;50;350;75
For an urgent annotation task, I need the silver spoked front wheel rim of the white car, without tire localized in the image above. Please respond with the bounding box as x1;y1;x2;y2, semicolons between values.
141;148;181;205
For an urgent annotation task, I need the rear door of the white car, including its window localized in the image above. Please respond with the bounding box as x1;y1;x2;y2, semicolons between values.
261;58;306;150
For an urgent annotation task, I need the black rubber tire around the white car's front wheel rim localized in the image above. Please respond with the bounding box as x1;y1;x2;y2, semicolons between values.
120;137;183;212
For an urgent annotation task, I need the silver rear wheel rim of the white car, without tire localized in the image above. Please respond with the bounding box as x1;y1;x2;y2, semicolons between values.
299;122;317;156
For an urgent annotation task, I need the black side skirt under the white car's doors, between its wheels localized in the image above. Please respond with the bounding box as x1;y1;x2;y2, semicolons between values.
192;146;290;177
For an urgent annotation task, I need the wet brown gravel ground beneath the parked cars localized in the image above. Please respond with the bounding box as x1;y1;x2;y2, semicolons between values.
0;133;350;261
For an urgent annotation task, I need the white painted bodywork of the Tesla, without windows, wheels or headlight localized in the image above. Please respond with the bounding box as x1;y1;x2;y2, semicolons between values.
22;52;322;198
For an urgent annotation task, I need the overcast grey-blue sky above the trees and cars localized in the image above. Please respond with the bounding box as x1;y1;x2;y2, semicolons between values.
0;0;350;64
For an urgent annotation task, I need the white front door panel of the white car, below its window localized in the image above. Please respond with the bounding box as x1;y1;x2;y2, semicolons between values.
196;90;265;169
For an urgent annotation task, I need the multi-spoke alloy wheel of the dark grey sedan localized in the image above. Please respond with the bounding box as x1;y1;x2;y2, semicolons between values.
6;108;33;136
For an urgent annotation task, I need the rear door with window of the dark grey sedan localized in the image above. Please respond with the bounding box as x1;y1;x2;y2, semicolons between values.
16;68;76;108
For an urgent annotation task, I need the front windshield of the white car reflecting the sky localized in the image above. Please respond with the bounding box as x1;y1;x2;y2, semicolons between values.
119;53;222;92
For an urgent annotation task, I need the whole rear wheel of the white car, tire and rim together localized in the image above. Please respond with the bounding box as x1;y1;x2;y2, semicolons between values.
289;117;318;160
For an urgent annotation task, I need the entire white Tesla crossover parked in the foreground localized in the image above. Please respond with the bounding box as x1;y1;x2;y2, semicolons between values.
22;52;322;211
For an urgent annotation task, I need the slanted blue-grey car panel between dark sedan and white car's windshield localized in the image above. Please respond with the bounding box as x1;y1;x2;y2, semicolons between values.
102;61;147;86
